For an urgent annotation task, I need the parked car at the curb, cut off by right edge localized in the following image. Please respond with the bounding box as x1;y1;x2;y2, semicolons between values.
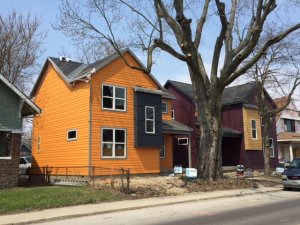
282;158;300;189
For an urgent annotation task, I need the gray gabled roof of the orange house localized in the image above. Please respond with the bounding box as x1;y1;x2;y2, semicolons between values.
31;48;171;96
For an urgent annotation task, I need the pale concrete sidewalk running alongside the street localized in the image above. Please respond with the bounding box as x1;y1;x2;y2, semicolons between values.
0;187;282;224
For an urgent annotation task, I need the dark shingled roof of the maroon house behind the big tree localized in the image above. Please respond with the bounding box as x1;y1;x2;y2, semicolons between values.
164;80;275;105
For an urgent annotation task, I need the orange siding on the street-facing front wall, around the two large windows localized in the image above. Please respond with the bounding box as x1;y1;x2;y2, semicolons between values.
92;54;160;173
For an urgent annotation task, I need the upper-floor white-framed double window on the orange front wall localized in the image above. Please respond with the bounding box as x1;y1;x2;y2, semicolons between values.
102;84;126;111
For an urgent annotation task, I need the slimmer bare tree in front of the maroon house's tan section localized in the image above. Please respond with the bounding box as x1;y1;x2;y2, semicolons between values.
248;35;300;175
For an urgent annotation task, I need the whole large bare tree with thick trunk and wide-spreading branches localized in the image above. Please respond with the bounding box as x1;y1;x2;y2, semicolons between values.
56;0;300;180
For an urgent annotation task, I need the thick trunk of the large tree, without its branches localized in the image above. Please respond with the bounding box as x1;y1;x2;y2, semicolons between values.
190;67;223;181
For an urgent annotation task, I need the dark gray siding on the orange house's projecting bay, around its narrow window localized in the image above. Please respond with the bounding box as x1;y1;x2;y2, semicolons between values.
134;92;162;148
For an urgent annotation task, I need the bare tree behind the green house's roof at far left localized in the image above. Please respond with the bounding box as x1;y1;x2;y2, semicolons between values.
0;11;46;91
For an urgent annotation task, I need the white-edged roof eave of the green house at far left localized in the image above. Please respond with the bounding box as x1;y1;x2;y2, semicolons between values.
0;74;41;116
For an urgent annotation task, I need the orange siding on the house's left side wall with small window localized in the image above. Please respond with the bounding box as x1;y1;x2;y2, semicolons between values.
32;64;89;171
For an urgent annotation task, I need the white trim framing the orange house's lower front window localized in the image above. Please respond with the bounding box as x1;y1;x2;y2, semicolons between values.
101;127;127;159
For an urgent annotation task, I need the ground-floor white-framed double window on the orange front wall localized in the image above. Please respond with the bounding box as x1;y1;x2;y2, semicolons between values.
102;128;126;158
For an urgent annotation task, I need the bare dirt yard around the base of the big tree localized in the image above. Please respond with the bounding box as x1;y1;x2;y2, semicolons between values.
95;172;281;199
